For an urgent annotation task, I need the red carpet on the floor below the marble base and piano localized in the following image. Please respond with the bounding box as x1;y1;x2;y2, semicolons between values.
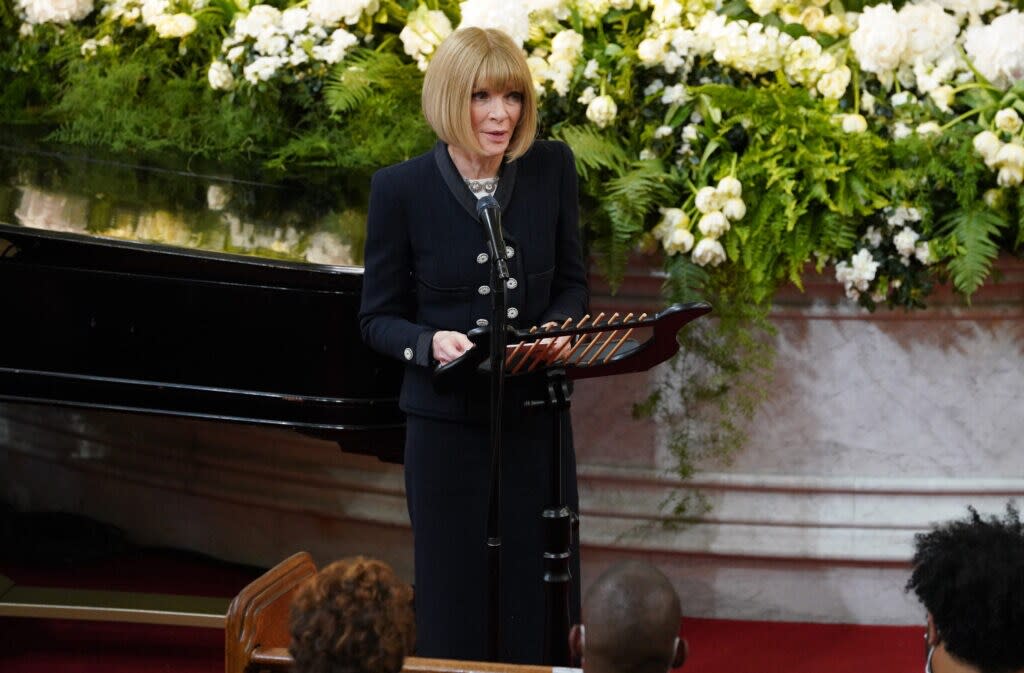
0;550;924;673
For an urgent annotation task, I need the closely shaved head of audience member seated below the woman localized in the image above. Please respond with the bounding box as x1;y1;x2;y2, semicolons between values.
569;561;686;673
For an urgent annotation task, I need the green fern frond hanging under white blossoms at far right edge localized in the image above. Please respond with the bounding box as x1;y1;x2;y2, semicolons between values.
940;205;1007;297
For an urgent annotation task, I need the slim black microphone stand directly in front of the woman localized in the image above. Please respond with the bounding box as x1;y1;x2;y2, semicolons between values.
486;215;509;662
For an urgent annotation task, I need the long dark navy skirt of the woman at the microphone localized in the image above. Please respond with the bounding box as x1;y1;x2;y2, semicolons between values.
406;403;580;664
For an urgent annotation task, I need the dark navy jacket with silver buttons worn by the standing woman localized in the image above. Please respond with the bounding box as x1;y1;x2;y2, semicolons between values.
359;140;588;421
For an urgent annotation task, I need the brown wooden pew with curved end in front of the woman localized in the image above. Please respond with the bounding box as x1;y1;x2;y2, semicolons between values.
224;551;572;673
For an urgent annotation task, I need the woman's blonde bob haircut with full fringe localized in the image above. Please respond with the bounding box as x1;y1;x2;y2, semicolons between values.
423;28;537;161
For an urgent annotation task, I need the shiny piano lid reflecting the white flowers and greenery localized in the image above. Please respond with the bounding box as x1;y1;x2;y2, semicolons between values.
0;133;370;267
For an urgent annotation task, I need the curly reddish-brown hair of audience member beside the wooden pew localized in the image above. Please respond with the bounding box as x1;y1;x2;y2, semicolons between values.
289;556;416;673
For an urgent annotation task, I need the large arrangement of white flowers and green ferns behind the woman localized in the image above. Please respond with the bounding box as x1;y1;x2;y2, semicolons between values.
0;0;1024;487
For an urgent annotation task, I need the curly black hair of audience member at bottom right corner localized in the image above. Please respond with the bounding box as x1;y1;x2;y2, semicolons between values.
906;503;1024;673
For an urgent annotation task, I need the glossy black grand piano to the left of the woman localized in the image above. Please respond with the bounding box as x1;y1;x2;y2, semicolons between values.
0;136;404;459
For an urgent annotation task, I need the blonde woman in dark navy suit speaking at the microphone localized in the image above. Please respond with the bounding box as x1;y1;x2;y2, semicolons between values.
359;29;588;663
